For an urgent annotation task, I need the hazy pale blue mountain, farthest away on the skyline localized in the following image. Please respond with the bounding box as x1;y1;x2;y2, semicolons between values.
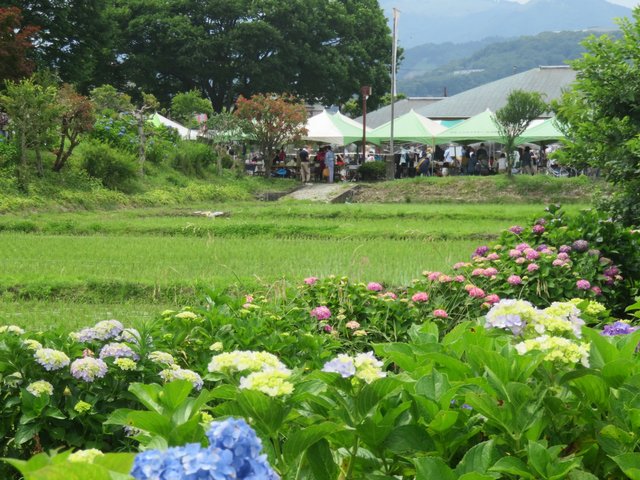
379;0;631;49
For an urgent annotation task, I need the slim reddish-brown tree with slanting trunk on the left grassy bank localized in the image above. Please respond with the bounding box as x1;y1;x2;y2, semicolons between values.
53;84;96;172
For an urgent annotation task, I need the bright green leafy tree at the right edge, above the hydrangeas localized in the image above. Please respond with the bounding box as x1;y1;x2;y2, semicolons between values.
554;12;640;225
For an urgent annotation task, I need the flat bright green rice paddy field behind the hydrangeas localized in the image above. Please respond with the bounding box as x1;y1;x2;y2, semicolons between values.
0;202;585;330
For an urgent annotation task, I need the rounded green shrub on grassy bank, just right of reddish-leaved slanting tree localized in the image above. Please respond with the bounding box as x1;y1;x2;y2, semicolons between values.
81;141;137;191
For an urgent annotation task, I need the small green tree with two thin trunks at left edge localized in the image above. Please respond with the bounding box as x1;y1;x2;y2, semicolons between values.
0;79;60;177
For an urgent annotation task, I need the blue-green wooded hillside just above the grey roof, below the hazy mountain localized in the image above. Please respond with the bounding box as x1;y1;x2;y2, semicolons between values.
398;32;608;97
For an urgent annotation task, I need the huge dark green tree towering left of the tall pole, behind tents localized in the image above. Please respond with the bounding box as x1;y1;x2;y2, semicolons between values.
114;0;391;111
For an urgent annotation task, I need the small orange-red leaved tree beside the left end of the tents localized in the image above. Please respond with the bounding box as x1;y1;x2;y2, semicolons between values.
234;93;307;174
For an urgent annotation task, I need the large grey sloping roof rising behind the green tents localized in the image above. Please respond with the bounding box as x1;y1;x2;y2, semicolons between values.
412;65;576;120
